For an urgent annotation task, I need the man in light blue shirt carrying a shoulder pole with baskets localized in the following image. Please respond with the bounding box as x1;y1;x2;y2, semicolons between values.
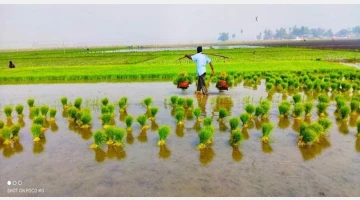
185;46;215;95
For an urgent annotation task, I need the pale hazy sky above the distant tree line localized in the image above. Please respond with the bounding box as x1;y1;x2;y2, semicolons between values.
0;4;360;49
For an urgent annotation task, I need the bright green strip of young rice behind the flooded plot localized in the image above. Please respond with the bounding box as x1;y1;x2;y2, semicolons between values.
0;47;360;84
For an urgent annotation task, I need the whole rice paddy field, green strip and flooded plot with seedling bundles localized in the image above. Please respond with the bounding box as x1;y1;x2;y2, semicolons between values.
0;45;360;197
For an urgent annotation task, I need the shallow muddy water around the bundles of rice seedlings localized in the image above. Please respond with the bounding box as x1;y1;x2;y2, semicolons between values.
0;83;360;196
